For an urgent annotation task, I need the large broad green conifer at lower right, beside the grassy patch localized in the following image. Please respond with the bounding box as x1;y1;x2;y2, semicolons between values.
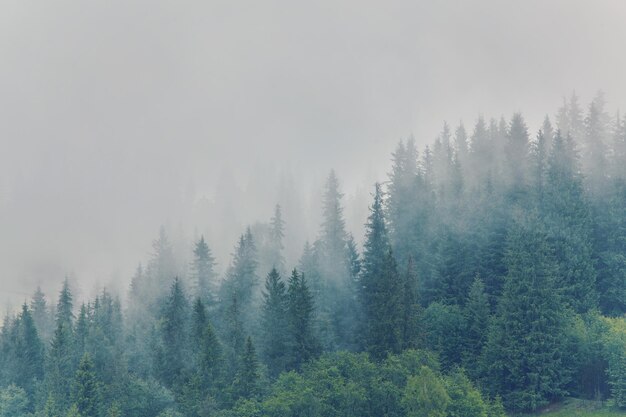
483;214;568;410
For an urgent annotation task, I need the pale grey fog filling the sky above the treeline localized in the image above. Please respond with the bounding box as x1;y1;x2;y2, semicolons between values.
0;0;626;308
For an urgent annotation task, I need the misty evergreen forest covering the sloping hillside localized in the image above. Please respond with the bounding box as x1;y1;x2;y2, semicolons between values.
0;93;626;417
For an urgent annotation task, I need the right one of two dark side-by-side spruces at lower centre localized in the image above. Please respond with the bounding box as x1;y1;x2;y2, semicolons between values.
287;269;320;369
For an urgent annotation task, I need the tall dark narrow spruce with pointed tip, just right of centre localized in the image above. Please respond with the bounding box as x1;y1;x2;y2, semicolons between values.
361;184;403;360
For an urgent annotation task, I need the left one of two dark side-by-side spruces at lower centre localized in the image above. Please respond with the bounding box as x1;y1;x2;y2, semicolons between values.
261;268;288;377
